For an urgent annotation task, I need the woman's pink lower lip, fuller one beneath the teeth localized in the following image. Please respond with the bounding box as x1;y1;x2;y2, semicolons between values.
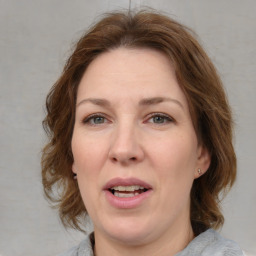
105;189;152;209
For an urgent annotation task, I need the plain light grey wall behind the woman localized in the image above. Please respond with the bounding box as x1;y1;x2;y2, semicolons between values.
0;0;256;256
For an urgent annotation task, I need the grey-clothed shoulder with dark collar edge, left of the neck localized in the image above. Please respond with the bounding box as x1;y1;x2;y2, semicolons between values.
57;233;94;256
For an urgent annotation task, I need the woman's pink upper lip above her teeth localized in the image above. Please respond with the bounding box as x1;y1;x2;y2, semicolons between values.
103;177;152;190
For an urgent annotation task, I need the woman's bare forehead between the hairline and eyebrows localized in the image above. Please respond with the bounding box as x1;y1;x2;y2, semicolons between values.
78;48;186;103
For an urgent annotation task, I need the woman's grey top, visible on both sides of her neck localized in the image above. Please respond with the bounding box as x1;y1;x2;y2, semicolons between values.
58;229;244;256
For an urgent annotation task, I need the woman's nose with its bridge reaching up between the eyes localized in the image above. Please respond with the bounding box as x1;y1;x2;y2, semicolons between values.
110;116;143;163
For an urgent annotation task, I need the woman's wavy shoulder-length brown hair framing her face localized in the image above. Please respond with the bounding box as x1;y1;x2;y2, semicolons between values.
42;11;236;234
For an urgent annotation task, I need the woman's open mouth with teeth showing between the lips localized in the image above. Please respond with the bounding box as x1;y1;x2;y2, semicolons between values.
108;185;148;198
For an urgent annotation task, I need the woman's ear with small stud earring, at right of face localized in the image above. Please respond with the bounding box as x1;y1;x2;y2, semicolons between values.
194;145;211;179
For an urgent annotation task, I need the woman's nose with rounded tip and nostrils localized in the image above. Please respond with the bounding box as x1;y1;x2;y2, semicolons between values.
109;121;144;165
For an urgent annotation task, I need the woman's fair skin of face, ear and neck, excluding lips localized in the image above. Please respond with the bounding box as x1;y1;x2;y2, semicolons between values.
72;48;210;256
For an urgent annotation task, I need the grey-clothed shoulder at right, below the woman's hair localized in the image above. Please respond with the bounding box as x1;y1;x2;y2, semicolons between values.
177;229;244;256
